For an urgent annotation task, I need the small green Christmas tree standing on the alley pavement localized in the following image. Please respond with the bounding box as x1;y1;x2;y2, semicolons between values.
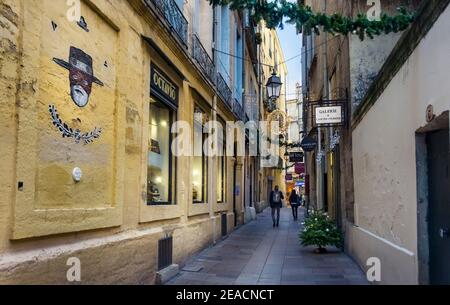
300;211;343;253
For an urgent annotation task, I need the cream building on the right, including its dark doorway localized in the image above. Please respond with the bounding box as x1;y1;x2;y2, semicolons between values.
349;1;450;284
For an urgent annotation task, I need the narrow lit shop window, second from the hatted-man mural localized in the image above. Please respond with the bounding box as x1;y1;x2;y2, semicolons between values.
192;106;208;204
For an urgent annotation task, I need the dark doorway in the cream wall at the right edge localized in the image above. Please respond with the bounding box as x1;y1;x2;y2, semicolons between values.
416;111;450;285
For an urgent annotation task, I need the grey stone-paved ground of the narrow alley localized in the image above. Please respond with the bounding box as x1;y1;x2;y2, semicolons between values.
168;209;367;285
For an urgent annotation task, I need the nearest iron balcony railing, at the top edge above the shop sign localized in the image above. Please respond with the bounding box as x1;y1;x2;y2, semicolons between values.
145;0;188;48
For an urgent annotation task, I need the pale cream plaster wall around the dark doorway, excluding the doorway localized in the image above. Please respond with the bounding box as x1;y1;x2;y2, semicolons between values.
350;4;450;284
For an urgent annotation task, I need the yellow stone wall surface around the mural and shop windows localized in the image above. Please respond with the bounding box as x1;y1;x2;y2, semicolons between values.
0;0;243;284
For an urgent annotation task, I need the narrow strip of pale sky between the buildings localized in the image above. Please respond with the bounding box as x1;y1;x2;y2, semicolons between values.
277;23;302;99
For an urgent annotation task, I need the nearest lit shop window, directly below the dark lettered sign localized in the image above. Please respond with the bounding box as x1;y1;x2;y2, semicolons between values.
147;99;175;205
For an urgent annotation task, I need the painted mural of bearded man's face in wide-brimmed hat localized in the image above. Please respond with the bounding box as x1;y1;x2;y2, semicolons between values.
53;47;104;108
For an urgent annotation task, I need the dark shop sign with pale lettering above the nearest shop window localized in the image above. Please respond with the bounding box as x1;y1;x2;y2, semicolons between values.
150;65;179;108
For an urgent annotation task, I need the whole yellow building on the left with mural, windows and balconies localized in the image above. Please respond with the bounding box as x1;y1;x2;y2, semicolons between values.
0;0;282;284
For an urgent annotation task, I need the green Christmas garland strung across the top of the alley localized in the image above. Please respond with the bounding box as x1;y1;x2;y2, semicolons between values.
209;0;416;40
